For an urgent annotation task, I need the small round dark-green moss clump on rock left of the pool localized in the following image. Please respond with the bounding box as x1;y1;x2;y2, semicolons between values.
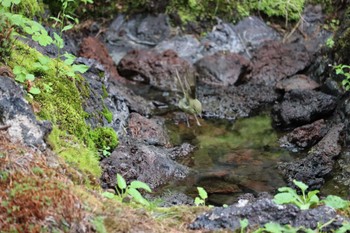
90;127;118;150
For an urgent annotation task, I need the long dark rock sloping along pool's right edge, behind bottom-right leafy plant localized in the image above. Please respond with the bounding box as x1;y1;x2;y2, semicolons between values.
278;124;344;190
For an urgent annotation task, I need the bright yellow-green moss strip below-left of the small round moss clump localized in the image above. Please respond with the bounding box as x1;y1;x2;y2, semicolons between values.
48;127;101;177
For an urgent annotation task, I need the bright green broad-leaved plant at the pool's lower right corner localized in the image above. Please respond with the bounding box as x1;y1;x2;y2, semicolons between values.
274;180;320;210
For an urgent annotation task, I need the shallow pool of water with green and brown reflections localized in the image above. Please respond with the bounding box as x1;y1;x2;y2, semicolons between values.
167;115;292;205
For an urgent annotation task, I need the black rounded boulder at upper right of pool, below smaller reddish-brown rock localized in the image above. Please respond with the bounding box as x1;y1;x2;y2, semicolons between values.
272;90;336;127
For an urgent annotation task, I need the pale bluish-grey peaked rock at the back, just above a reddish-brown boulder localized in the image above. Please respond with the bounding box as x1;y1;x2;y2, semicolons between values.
201;21;245;56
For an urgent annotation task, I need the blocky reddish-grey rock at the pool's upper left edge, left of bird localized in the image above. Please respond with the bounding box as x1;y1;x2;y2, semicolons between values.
128;113;170;147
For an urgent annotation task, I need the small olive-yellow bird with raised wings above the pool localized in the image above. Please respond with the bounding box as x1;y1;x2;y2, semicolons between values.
176;70;202;127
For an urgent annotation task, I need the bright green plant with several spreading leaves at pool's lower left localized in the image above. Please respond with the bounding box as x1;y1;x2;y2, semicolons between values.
102;174;152;206
